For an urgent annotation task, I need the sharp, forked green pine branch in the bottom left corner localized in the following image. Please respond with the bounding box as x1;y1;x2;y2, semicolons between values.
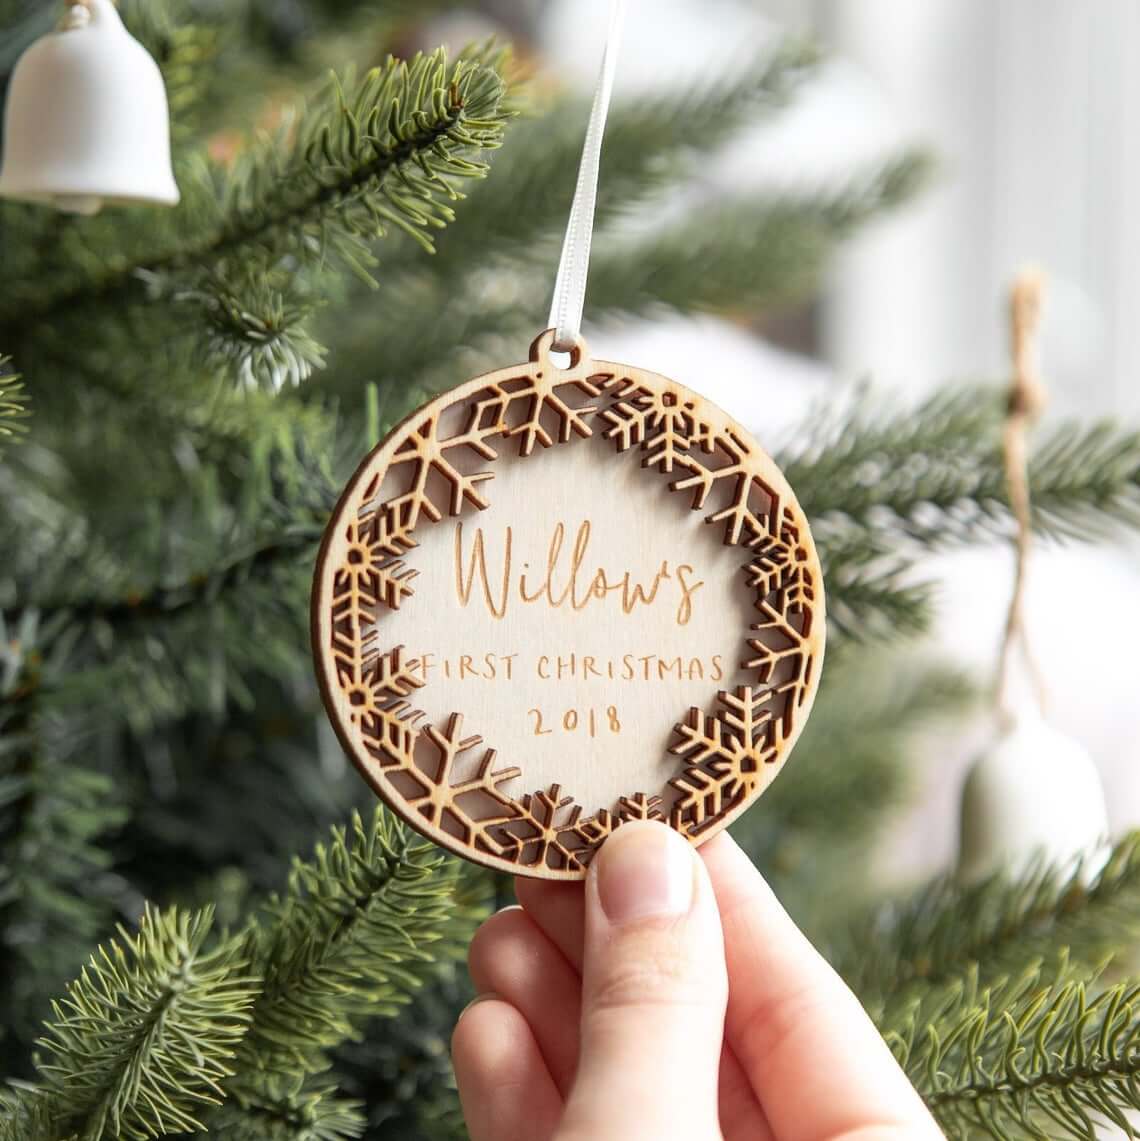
0;809;477;1141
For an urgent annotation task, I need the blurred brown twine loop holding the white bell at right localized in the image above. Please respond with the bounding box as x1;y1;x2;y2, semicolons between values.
997;269;1048;718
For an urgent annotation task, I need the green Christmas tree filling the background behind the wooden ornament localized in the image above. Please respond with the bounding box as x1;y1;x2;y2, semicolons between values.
0;0;1140;1141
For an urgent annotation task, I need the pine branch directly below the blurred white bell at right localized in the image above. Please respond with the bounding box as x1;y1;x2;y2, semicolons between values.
838;833;1140;1009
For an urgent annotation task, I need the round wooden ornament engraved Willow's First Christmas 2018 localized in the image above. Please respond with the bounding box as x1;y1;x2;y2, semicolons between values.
313;331;825;880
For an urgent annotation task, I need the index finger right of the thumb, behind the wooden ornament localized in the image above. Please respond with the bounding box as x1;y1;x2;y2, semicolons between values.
701;833;943;1141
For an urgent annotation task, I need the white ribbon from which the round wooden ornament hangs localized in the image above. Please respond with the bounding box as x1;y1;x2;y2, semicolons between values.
549;0;625;350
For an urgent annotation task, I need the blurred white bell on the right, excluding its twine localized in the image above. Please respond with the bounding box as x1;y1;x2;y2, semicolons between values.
959;707;1108;882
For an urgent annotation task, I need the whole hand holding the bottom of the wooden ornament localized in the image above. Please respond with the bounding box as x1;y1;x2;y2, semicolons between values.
452;823;943;1141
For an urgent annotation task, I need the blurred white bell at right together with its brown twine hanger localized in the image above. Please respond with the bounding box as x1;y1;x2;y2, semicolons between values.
959;270;1108;882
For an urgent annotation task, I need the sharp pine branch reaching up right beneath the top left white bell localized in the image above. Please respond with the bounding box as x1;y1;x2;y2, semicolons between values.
0;51;506;383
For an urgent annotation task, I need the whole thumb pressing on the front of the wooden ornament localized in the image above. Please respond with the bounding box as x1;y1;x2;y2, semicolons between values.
558;822;728;1141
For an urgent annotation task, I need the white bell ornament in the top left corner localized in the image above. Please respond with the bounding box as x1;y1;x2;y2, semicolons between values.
0;0;179;215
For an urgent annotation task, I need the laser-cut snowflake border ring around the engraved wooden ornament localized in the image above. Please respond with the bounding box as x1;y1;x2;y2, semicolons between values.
318;333;823;876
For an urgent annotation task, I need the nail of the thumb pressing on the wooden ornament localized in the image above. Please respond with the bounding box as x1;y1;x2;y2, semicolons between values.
593;820;694;924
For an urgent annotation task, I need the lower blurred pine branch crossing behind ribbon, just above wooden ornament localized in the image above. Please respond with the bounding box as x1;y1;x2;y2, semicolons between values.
325;155;927;400
